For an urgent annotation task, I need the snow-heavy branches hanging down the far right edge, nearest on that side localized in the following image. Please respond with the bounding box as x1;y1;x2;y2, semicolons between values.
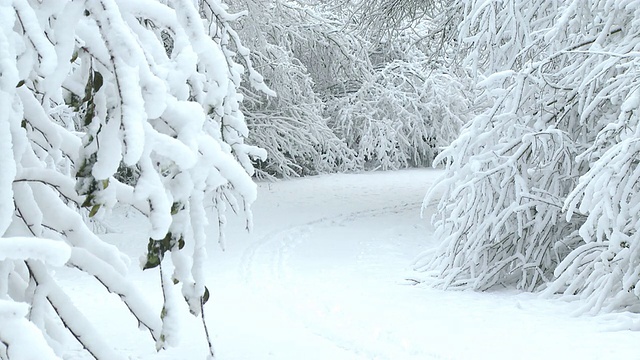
549;0;640;312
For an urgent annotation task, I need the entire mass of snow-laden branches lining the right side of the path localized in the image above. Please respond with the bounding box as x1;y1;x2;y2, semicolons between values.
420;0;640;311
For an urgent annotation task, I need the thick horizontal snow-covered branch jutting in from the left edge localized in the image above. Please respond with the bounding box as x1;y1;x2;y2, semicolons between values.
0;237;71;266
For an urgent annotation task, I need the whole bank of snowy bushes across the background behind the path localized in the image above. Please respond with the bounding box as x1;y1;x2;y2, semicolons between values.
225;0;470;176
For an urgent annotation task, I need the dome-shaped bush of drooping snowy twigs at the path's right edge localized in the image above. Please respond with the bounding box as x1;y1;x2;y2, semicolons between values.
418;76;577;290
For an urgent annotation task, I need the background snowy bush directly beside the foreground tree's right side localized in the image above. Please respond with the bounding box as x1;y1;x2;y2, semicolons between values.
229;0;357;177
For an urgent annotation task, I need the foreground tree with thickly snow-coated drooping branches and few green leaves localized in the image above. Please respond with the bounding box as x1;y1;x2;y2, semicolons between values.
0;0;268;359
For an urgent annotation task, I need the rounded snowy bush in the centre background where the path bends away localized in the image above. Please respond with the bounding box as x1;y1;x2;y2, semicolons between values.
327;1;474;169
